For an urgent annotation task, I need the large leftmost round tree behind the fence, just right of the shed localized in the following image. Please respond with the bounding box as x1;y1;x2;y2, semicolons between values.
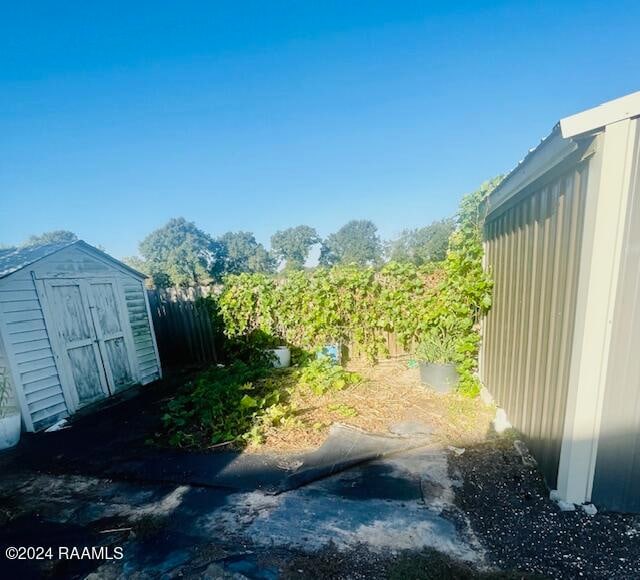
140;218;225;286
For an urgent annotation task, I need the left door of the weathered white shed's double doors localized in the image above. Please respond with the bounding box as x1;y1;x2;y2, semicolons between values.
45;280;109;407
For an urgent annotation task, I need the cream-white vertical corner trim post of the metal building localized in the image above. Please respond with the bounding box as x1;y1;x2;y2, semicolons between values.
558;120;637;503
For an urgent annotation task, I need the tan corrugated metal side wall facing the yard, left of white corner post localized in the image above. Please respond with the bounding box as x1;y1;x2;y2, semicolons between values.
481;160;589;487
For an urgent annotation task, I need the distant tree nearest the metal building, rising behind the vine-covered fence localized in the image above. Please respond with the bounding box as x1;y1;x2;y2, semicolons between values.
388;219;455;266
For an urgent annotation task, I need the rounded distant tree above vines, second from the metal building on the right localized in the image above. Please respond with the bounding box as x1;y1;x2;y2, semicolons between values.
320;220;382;266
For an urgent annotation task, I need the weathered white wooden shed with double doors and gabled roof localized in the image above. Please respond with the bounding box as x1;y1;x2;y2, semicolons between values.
0;241;162;431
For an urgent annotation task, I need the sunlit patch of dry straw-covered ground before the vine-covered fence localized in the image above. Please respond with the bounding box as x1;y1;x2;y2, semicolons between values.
252;357;495;453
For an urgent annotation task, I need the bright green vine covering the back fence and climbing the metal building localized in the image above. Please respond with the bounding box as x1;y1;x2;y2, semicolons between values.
219;178;500;395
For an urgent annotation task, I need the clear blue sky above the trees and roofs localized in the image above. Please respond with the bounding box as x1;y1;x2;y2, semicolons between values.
0;0;640;257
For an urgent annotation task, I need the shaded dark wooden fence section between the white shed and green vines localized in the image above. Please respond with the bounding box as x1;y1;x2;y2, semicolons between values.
147;286;220;365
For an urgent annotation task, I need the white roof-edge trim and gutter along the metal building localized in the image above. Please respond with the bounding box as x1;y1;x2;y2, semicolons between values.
487;91;640;214
